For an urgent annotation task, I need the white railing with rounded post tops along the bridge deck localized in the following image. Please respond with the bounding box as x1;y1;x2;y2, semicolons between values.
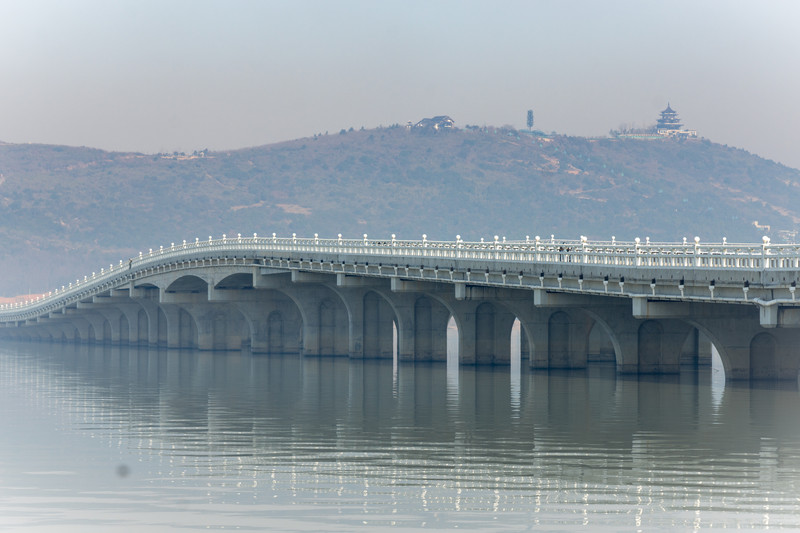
0;233;800;320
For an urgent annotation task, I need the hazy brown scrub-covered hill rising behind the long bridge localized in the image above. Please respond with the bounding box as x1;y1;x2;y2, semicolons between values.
0;127;800;295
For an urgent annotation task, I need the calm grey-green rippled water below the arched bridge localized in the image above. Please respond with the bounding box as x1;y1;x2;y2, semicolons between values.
0;343;800;532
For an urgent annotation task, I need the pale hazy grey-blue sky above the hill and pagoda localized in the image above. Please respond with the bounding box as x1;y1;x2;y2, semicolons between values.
0;0;800;168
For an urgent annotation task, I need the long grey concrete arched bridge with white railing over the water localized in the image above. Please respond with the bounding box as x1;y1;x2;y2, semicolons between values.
0;234;800;380
